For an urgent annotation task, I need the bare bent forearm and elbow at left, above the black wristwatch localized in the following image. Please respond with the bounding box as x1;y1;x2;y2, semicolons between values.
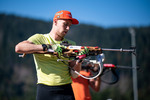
15;40;43;53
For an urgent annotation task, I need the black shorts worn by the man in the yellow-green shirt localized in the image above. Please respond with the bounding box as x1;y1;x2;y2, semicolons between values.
36;84;75;100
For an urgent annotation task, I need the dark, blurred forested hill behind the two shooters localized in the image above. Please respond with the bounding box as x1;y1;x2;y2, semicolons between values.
0;14;150;100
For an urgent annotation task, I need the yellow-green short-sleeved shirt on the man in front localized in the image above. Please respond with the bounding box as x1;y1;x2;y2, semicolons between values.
28;34;75;86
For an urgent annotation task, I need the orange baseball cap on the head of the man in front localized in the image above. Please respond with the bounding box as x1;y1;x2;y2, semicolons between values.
53;10;79;24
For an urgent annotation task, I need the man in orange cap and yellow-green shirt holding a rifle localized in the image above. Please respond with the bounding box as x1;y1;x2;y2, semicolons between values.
15;10;85;100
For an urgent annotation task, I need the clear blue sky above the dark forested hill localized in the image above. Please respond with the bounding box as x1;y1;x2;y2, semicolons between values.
0;0;150;27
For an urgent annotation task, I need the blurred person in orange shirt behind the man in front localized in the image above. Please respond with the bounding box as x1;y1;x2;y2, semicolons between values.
72;64;101;100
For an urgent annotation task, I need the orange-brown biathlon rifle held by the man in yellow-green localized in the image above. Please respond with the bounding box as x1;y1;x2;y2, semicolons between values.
19;41;135;59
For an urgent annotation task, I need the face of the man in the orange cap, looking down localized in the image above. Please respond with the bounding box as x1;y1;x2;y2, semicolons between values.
56;19;72;38
